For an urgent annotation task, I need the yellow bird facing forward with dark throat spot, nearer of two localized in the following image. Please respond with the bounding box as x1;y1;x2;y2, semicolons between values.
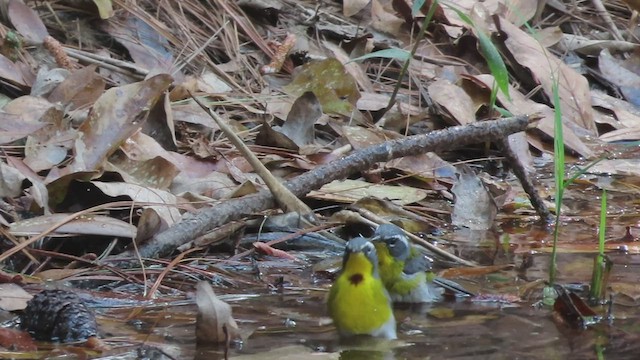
327;237;397;339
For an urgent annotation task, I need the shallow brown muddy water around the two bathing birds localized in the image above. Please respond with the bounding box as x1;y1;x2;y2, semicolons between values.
91;205;640;359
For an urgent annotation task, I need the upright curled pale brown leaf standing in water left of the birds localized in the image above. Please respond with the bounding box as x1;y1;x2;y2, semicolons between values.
196;281;238;344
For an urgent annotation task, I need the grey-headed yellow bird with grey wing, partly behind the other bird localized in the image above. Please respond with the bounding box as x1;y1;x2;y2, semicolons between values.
371;224;444;303
